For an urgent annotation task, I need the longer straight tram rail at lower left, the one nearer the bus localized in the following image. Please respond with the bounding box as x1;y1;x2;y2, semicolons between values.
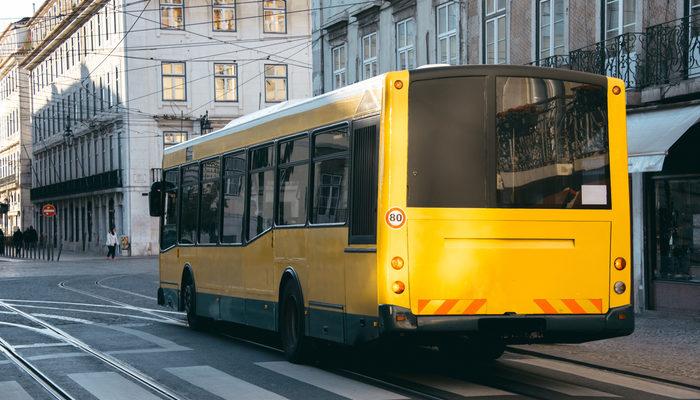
0;301;189;400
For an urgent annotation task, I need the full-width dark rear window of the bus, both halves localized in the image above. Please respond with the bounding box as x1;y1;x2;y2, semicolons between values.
407;76;611;209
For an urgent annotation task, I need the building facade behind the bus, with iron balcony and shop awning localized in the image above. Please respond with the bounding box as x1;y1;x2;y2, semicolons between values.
313;0;700;313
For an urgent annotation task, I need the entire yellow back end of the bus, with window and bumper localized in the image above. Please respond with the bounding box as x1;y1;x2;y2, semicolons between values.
377;66;634;343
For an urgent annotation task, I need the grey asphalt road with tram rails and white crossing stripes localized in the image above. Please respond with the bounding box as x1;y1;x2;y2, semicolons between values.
0;258;700;400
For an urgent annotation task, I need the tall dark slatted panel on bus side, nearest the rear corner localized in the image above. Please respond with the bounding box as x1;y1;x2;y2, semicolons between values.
348;117;379;244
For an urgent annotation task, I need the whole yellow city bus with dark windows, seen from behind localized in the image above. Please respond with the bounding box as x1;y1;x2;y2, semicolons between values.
149;66;634;361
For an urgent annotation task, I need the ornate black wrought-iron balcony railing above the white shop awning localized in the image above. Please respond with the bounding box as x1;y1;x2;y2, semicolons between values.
532;14;700;89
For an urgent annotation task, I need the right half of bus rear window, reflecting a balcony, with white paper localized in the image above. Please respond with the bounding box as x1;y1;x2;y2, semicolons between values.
496;77;610;209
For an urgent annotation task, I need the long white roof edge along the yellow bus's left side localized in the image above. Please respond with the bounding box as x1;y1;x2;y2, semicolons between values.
164;74;386;154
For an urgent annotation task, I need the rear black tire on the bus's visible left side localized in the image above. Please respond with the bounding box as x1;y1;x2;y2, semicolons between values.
279;279;311;364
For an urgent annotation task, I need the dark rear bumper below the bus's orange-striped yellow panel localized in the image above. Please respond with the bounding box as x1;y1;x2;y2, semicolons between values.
379;304;634;343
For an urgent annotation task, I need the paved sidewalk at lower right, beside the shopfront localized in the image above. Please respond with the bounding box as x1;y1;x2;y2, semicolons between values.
512;311;700;387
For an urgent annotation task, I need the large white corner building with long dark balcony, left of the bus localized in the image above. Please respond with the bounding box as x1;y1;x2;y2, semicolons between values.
22;0;311;255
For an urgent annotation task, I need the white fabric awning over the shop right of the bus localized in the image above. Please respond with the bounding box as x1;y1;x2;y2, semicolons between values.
627;105;700;173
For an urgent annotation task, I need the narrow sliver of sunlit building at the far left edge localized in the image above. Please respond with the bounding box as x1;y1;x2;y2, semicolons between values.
0;18;33;235
